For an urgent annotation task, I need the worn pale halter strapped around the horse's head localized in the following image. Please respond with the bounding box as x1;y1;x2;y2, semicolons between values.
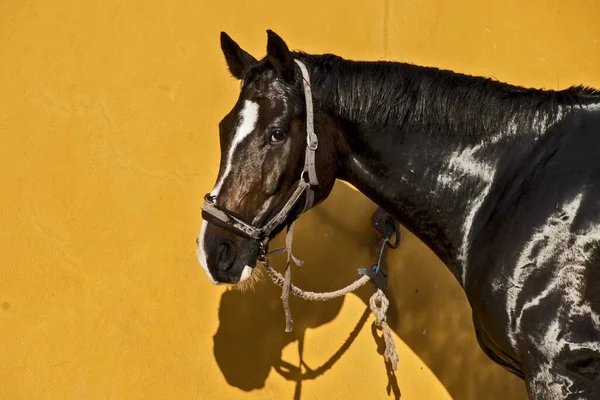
202;60;319;257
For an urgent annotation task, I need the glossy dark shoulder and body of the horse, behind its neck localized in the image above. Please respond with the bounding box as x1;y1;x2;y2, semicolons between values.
465;111;600;399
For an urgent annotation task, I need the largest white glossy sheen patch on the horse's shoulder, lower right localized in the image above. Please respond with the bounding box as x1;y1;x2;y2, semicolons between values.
507;193;600;399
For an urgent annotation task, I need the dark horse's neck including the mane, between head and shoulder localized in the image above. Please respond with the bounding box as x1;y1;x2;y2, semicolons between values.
305;56;596;286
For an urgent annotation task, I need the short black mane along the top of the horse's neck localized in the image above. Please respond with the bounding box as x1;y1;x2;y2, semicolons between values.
294;52;600;142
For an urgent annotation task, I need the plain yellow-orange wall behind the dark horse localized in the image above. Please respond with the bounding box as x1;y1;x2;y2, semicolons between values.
0;0;600;400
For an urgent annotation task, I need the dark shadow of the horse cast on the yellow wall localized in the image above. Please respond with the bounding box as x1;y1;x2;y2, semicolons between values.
213;183;526;400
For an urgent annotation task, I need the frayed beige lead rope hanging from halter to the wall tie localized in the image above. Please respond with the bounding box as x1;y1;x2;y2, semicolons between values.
261;228;398;371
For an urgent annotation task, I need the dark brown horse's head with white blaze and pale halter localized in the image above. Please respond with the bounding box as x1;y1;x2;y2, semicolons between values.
197;31;336;283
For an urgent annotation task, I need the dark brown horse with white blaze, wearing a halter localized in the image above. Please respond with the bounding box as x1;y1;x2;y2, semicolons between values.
196;30;600;400
